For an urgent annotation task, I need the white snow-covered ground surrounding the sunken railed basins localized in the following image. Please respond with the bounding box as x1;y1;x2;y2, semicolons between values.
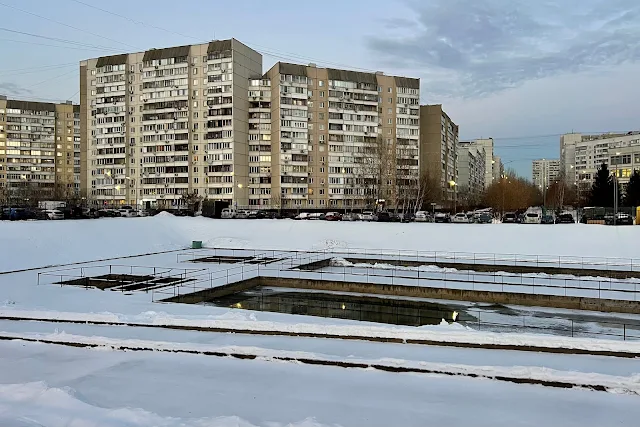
0;215;640;427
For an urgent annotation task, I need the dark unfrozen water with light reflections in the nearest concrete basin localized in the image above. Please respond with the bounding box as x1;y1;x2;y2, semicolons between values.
205;287;470;326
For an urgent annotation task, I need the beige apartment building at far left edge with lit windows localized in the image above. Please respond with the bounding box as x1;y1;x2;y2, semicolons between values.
0;96;80;203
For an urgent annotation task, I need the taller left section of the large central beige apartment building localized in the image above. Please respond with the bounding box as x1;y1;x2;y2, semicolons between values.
80;39;262;208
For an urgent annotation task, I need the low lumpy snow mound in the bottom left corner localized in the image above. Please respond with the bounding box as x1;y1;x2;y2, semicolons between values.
0;382;330;427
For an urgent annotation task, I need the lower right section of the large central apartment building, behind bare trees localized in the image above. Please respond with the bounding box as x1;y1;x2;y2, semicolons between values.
266;62;420;209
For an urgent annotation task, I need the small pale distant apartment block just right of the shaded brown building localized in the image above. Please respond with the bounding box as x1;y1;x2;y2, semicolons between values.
458;142;486;197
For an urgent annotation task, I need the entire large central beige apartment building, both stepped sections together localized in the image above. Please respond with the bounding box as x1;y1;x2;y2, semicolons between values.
80;40;420;209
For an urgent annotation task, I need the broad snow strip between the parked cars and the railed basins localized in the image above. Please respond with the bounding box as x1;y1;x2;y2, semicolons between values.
0;214;640;271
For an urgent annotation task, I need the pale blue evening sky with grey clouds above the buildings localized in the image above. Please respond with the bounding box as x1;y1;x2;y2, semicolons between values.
0;0;640;177
